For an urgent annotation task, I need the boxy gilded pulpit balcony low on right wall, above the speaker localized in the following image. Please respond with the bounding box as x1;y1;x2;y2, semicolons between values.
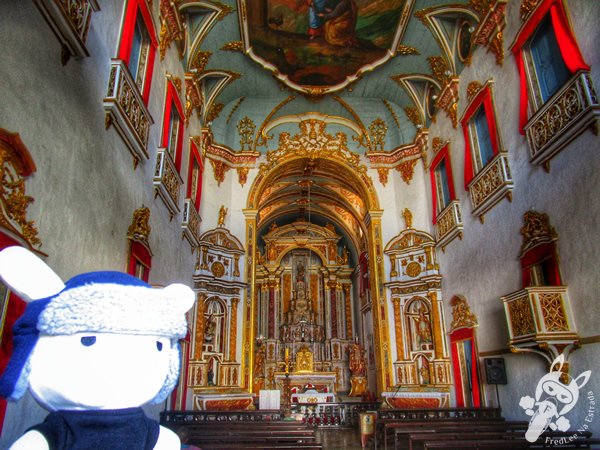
502;286;578;349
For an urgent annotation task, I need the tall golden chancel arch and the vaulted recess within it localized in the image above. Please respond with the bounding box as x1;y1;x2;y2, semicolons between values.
242;149;391;392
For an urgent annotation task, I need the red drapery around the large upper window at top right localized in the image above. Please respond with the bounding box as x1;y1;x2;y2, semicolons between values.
512;0;590;134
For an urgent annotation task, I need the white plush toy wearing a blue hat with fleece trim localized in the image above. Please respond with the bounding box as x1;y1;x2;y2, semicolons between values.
0;247;194;450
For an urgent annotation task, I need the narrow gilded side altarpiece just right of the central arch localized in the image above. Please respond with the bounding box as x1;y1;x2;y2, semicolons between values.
382;227;451;408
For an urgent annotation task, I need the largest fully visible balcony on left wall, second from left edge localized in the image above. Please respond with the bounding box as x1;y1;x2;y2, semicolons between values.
104;59;154;166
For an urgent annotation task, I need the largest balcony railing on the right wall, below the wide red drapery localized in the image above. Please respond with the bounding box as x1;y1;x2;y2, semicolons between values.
525;72;600;166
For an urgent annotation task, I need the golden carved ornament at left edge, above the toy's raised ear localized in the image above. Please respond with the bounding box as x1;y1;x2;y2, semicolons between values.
0;133;41;250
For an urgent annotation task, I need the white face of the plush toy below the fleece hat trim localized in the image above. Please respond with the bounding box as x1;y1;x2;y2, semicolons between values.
29;333;171;410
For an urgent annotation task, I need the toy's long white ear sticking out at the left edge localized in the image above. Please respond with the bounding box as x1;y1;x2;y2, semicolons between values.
0;247;65;302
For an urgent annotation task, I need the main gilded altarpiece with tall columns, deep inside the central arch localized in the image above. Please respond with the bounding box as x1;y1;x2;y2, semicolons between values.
252;220;354;394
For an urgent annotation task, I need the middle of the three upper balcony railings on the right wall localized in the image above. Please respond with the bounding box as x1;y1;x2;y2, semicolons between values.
469;153;513;222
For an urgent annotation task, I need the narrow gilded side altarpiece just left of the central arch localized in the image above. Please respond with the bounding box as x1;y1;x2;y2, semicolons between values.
188;224;252;409
